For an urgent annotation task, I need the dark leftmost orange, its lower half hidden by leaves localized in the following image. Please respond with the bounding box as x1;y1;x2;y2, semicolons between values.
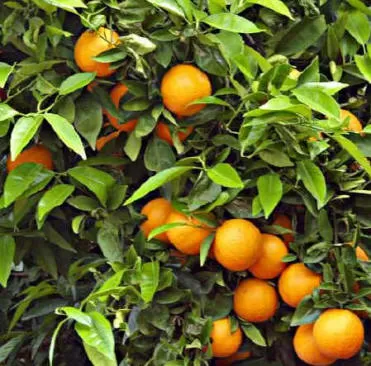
6;145;54;173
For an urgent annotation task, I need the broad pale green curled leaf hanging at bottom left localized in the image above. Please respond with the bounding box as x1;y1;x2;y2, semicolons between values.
75;311;116;361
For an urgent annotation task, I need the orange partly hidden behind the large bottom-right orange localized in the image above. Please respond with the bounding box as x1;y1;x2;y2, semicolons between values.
294;324;336;366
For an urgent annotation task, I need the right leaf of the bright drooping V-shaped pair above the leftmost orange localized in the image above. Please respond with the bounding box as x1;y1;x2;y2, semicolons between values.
44;113;86;159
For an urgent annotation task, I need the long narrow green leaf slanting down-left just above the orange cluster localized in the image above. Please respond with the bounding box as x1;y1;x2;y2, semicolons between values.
124;166;193;205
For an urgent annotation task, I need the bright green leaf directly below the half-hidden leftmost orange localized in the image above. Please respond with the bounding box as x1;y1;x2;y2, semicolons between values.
3;163;43;207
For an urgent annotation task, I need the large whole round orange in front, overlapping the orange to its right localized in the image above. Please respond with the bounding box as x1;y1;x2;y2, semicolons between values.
214;219;262;271
